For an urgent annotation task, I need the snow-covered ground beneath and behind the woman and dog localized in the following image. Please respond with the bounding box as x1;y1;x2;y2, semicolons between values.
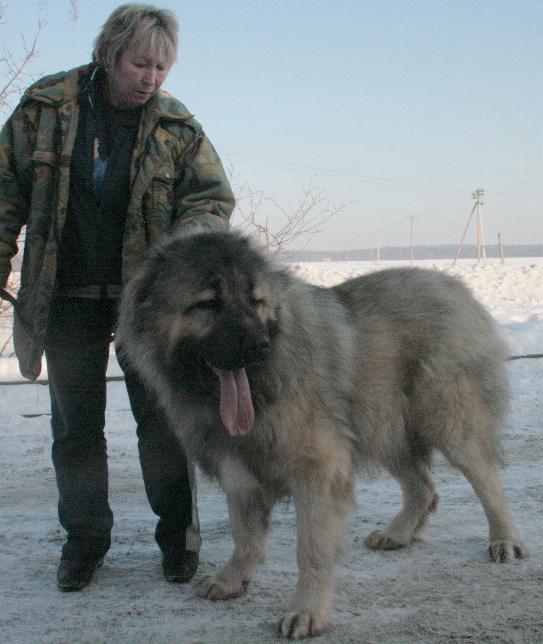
0;259;543;644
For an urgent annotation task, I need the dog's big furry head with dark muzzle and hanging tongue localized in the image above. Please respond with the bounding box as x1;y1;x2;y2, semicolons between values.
119;233;285;435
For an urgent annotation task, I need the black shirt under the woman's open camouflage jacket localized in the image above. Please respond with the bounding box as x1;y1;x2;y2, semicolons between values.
57;73;142;290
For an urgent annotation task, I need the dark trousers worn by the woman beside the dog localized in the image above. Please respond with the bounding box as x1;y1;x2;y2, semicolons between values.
45;298;198;557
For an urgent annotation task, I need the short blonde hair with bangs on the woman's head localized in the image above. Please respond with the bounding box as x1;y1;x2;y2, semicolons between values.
92;4;179;68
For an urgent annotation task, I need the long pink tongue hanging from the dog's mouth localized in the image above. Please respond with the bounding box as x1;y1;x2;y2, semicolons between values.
213;367;255;436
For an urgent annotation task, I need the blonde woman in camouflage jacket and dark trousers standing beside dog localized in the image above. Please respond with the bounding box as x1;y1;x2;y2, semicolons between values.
0;4;234;591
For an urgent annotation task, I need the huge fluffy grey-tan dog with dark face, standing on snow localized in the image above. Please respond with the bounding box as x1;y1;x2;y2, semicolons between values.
117;233;525;638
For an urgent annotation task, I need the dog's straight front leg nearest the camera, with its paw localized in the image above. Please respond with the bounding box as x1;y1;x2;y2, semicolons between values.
279;456;353;639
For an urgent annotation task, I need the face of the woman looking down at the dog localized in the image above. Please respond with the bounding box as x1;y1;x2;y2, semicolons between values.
107;50;171;110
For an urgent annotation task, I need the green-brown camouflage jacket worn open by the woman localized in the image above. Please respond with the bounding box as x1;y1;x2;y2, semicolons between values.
0;65;234;380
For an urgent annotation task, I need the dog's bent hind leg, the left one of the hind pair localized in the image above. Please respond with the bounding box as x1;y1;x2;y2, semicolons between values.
364;455;439;550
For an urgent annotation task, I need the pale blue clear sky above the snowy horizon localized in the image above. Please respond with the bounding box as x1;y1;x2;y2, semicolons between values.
0;0;543;250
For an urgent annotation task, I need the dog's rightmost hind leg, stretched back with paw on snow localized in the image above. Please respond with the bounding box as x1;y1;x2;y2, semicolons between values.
443;432;528;563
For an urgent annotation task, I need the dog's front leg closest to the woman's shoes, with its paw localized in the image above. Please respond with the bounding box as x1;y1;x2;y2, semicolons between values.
196;461;273;599
